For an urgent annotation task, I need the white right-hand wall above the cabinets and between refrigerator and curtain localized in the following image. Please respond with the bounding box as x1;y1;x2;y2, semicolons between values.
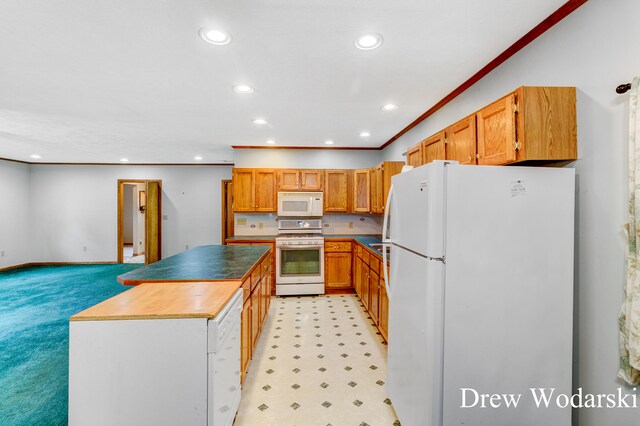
383;0;640;425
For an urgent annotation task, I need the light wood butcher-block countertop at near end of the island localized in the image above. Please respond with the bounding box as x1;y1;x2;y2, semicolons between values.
70;281;240;321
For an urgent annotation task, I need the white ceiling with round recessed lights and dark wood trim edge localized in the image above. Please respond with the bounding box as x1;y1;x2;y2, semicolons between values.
0;0;565;163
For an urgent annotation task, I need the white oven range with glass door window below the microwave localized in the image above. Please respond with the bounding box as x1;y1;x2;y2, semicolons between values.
276;218;324;296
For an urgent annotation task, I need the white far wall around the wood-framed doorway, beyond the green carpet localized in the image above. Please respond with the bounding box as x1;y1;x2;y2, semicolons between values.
29;165;231;262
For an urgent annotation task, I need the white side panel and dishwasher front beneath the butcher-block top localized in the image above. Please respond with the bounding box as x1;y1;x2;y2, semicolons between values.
69;289;242;426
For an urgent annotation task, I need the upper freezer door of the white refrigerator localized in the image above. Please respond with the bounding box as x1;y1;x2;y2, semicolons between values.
390;161;449;257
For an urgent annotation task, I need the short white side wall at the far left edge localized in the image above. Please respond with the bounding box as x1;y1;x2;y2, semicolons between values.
0;160;30;269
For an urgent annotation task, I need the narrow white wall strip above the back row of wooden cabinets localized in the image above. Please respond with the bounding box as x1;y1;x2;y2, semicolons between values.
233;148;381;169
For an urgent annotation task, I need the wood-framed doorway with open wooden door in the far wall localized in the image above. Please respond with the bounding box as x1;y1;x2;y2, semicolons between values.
118;179;162;265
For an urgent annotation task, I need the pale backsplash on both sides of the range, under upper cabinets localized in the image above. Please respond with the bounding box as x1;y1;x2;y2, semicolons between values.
234;213;382;235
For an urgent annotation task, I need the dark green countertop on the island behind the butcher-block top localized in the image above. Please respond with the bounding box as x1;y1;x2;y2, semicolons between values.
118;246;269;285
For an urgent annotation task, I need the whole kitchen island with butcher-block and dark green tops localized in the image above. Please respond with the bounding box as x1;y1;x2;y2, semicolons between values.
69;246;273;424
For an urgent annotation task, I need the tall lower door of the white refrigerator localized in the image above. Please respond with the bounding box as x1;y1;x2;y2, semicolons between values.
387;245;444;425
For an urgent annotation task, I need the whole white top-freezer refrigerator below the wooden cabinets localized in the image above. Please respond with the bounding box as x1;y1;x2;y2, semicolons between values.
383;161;575;426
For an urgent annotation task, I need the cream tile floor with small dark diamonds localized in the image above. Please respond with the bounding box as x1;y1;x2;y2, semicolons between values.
234;295;400;426
